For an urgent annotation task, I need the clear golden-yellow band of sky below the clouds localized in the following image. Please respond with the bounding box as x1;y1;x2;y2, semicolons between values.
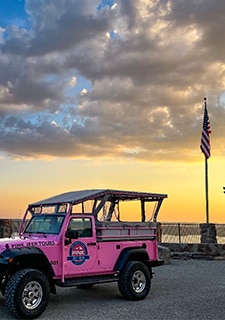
0;159;225;223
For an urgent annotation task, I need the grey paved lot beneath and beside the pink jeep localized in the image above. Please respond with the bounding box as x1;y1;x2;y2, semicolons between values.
0;260;225;320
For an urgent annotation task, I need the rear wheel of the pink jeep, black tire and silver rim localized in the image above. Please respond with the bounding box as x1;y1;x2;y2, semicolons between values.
118;261;151;300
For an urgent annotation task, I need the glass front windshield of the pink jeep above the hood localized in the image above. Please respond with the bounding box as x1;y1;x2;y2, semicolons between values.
24;214;65;234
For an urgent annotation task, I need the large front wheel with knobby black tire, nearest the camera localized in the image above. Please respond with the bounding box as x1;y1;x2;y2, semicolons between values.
5;269;50;319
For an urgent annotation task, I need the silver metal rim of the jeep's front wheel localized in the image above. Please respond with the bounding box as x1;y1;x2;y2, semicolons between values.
22;281;43;310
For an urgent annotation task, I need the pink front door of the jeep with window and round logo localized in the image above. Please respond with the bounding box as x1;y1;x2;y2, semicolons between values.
64;216;98;276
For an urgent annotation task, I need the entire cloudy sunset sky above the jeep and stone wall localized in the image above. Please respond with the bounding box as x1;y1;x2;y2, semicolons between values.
0;0;225;223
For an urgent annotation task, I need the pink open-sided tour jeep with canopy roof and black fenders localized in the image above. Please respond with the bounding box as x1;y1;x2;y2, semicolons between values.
0;190;167;319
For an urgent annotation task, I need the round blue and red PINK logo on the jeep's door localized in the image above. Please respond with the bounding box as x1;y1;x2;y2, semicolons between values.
67;241;90;266
